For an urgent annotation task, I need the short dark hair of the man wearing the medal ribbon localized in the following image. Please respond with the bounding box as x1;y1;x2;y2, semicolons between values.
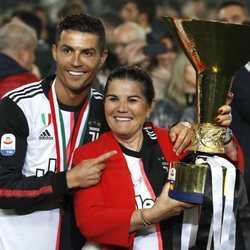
56;14;106;52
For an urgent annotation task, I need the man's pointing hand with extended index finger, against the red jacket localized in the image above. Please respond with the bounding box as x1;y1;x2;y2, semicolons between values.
66;150;117;189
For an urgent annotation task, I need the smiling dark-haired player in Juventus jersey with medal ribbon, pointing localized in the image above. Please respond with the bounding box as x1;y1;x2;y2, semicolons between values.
0;14;189;250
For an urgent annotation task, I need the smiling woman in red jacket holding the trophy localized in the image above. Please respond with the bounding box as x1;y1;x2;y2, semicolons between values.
73;66;242;249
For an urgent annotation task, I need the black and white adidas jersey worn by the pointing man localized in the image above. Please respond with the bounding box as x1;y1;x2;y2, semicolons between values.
0;76;107;250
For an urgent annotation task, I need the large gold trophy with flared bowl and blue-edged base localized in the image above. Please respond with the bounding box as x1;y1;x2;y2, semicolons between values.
162;17;250;203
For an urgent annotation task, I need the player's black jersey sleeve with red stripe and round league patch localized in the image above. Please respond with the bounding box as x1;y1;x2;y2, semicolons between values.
0;97;69;209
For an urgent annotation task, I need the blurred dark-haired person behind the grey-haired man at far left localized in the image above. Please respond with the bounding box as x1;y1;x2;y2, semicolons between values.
11;10;53;78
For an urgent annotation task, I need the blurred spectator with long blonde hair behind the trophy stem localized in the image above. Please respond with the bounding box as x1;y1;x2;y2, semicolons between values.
150;50;196;128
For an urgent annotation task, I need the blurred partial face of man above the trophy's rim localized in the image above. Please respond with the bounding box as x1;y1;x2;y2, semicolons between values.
218;5;246;24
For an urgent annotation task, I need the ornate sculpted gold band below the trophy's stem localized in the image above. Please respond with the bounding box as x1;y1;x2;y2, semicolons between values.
188;123;226;154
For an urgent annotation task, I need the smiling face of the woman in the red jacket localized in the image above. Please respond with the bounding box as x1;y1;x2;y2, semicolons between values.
104;79;151;139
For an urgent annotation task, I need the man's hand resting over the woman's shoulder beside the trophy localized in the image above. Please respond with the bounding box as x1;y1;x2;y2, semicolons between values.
169;122;191;155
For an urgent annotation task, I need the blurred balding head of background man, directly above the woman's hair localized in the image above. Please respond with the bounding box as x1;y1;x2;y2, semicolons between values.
114;22;146;65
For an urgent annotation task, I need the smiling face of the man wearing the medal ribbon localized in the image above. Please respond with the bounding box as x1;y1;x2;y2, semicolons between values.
52;30;107;101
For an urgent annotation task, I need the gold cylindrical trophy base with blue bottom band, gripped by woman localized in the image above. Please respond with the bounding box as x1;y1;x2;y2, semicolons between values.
168;162;209;204
